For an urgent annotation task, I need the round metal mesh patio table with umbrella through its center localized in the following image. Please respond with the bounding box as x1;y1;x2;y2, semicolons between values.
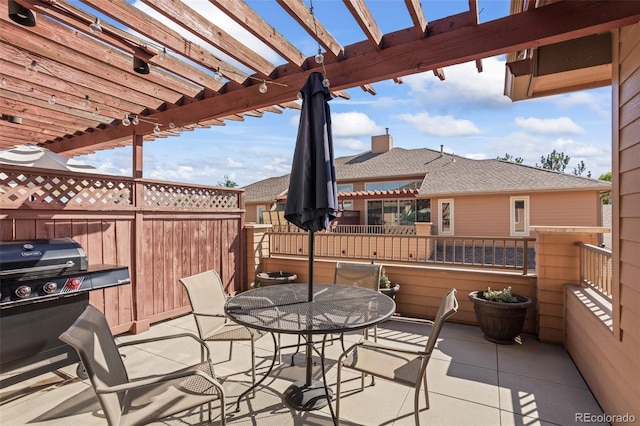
225;283;396;415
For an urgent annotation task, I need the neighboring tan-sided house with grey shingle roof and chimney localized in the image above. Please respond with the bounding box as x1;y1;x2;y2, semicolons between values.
244;133;611;237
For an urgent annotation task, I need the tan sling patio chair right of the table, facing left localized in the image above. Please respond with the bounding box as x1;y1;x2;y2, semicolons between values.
336;288;458;425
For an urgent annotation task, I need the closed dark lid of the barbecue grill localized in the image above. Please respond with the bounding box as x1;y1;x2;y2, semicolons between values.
0;238;88;281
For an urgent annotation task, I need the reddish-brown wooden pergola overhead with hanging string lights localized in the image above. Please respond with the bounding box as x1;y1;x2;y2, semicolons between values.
0;0;640;156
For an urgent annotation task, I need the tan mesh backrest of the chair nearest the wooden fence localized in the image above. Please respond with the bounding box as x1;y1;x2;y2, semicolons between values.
180;269;226;339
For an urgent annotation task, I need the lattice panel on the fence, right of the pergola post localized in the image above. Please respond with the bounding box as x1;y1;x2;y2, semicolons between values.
143;182;239;210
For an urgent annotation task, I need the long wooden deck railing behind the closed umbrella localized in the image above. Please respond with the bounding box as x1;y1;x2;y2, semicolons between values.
269;232;535;275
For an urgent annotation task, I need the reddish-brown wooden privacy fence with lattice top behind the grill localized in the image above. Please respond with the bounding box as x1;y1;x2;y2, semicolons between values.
0;165;245;333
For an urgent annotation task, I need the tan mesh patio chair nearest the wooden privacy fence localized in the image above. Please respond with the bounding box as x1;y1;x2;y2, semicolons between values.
180;270;265;396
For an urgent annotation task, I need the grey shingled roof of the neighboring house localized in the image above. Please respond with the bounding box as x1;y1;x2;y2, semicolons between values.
244;148;611;203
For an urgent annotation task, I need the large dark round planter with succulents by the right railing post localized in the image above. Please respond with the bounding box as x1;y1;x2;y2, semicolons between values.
469;286;532;345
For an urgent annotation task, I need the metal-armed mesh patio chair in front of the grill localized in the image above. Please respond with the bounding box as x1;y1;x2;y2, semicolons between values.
59;305;226;425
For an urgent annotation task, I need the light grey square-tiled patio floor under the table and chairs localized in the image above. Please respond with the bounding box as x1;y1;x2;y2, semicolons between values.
0;315;602;426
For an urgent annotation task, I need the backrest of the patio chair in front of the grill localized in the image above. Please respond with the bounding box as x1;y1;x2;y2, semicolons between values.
59;305;129;424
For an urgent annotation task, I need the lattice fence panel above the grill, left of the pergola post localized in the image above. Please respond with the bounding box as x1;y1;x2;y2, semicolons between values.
0;170;133;208
